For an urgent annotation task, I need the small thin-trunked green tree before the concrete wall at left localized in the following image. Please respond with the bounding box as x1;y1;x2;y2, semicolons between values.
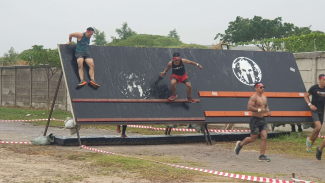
20;45;61;111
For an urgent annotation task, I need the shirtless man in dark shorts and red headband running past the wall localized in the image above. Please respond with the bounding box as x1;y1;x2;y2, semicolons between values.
235;82;271;162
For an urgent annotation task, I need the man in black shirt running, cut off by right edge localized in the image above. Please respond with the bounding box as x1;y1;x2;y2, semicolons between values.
304;74;325;152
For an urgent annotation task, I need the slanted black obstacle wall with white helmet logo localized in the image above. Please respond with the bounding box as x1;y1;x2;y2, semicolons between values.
58;45;311;124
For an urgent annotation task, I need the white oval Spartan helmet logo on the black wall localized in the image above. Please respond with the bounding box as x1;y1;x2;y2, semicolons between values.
232;57;262;86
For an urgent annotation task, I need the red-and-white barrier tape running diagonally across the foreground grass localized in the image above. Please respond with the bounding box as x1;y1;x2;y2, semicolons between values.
80;145;313;183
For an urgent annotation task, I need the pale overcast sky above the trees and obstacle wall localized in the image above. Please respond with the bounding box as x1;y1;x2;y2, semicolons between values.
0;0;325;54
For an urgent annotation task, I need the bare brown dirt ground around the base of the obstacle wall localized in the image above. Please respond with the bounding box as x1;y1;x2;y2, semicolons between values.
0;122;325;183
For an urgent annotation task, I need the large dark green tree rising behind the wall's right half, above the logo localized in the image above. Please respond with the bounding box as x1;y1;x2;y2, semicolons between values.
214;16;311;51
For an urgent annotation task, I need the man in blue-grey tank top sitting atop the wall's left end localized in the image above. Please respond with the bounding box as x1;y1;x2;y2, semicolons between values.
68;27;99;88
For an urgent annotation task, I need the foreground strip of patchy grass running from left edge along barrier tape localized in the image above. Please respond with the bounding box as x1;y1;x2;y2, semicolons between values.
0;144;245;182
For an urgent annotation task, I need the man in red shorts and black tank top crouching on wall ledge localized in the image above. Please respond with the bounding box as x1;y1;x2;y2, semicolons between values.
160;53;203;103
